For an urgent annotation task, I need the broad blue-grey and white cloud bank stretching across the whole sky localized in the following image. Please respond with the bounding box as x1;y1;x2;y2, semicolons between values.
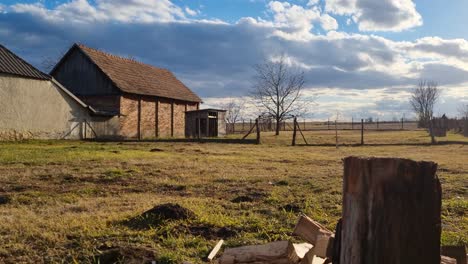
0;0;468;116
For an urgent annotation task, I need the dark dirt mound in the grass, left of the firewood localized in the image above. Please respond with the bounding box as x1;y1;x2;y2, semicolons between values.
124;203;196;229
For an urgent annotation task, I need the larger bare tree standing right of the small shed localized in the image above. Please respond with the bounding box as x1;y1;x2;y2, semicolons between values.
252;55;305;135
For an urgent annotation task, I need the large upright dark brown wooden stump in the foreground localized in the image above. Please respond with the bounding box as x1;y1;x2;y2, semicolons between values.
339;157;442;264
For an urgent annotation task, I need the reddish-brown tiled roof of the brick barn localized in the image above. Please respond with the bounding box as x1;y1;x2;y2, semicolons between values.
76;44;201;102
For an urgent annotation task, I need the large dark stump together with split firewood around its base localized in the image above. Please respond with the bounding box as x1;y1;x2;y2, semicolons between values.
203;157;466;264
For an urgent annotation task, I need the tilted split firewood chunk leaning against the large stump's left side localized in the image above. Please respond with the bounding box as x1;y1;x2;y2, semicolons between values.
293;215;333;245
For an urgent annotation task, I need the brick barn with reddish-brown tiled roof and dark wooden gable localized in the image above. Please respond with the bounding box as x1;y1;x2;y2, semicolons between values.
50;44;201;139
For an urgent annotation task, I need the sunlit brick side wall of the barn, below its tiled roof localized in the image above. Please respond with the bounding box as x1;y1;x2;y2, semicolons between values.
120;94;197;139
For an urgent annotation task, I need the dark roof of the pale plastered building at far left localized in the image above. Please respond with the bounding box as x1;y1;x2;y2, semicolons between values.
0;45;51;80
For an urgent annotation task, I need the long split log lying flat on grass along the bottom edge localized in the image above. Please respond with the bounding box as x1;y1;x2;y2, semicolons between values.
219;241;300;264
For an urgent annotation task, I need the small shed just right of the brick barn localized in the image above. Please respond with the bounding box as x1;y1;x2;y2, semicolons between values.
185;109;226;138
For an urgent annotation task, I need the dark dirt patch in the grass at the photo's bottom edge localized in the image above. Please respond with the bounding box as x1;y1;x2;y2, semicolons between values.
95;247;158;264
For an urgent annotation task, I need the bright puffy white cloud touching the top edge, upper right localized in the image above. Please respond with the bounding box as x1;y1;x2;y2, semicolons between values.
325;0;423;31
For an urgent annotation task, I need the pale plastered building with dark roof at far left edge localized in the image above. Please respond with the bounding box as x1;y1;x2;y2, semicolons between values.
0;45;93;140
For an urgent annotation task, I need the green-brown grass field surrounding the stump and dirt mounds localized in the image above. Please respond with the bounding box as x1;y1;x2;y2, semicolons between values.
0;131;468;263
